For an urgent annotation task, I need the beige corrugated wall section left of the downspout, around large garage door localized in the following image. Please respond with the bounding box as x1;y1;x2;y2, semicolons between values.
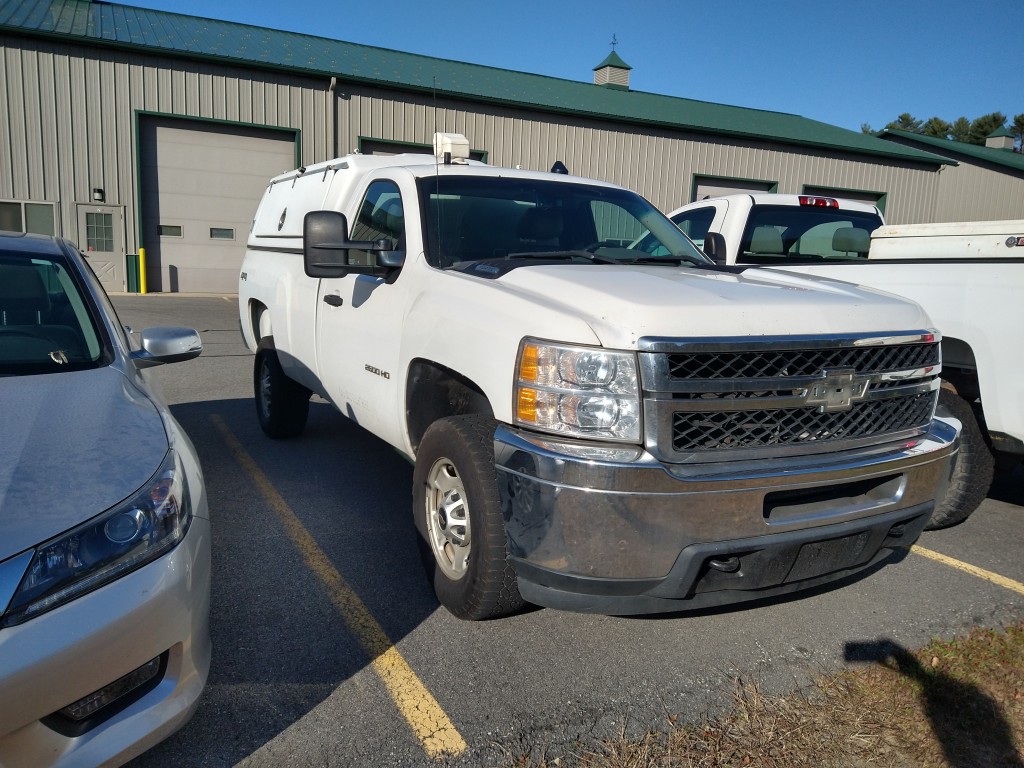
0;37;333;253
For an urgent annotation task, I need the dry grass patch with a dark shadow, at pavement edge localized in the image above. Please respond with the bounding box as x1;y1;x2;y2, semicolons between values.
521;625;1024;768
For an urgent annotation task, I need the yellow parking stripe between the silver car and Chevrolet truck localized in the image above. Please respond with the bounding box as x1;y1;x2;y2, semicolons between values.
210;415;467;758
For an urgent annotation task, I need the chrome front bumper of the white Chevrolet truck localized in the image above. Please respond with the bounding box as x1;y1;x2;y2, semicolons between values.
495;418;959;614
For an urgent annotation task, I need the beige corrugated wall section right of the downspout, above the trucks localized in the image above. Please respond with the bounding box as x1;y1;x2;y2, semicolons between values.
339;86;939;223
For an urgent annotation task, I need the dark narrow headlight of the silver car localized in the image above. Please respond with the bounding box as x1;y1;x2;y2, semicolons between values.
0;451;191;627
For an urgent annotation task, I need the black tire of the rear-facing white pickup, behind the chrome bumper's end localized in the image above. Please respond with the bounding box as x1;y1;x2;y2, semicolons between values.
925;387;994;530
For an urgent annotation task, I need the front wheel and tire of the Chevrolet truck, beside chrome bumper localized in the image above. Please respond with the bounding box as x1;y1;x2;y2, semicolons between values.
413;416;524;621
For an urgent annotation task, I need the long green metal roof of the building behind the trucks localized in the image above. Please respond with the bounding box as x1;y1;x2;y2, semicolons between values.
0;0;949;166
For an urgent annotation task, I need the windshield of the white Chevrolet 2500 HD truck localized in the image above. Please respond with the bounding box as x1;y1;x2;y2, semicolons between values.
419;176;711;268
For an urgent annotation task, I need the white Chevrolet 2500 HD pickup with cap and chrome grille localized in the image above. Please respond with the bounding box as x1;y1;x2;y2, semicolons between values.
239;135;959;620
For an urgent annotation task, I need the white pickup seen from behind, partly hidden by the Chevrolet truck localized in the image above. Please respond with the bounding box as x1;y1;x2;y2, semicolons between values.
659;194;1024;527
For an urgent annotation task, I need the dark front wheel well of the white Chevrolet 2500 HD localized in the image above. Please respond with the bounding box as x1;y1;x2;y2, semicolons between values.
406;360;494;451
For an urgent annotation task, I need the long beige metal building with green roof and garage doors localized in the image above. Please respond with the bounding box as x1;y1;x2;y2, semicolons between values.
0;0;955;292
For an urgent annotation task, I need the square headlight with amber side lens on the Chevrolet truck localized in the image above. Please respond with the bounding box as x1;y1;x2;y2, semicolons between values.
515;339;640;442
